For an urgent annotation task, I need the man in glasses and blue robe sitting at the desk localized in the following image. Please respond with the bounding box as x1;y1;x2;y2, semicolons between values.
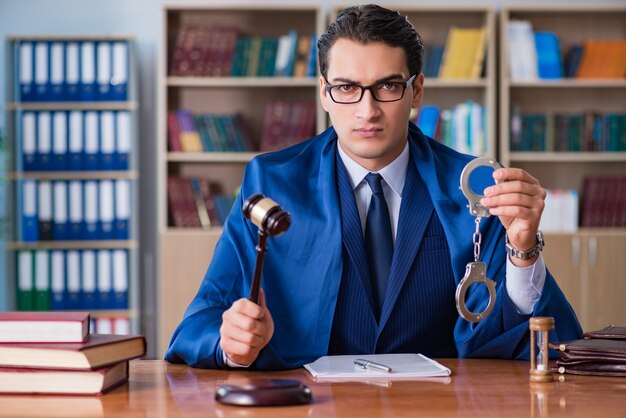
166;5;581;370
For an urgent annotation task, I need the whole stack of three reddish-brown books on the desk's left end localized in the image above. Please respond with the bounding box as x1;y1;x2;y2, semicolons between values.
0;312;146;395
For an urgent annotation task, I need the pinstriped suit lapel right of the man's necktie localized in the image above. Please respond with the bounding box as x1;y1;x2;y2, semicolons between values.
378;159;433;335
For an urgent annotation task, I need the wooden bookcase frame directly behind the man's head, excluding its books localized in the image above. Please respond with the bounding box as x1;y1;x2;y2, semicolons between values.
328;3;497;156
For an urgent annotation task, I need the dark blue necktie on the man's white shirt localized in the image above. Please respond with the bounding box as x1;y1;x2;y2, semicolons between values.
365;173;393;317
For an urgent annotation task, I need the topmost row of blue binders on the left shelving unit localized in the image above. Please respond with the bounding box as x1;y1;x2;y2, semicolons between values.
15;40;129;102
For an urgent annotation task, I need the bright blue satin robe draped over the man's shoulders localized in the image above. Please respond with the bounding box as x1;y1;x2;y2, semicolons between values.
165;123;581;369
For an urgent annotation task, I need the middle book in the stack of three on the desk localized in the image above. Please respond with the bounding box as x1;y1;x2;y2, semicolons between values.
0;334;146;370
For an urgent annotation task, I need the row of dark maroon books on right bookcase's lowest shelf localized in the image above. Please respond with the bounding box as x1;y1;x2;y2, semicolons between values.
580;175;626;227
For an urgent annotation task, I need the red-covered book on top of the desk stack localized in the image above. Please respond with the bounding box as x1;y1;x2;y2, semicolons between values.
0;312;89;343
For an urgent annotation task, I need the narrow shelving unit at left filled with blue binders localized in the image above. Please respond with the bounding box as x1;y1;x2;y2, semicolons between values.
3;35;141;333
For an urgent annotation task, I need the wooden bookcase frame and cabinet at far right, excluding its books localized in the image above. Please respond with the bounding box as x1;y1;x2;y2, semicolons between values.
499;4;626;330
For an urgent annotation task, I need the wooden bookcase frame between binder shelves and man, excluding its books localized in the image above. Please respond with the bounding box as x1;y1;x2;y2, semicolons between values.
157;3;327;356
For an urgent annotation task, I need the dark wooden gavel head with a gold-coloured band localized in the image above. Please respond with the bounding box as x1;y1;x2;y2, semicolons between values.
241;193;291;237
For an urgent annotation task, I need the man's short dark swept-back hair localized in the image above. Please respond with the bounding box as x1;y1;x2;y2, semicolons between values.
317;4;424;78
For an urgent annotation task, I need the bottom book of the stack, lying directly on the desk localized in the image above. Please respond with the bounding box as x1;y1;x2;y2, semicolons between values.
0;361;128;395
